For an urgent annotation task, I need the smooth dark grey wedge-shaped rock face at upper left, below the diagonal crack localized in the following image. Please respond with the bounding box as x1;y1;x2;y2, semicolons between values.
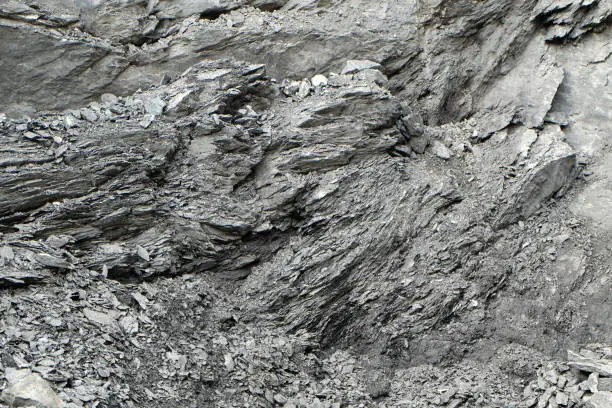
0;20;128;117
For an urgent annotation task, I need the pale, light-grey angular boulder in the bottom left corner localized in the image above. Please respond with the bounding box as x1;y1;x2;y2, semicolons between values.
2;368;64;408
